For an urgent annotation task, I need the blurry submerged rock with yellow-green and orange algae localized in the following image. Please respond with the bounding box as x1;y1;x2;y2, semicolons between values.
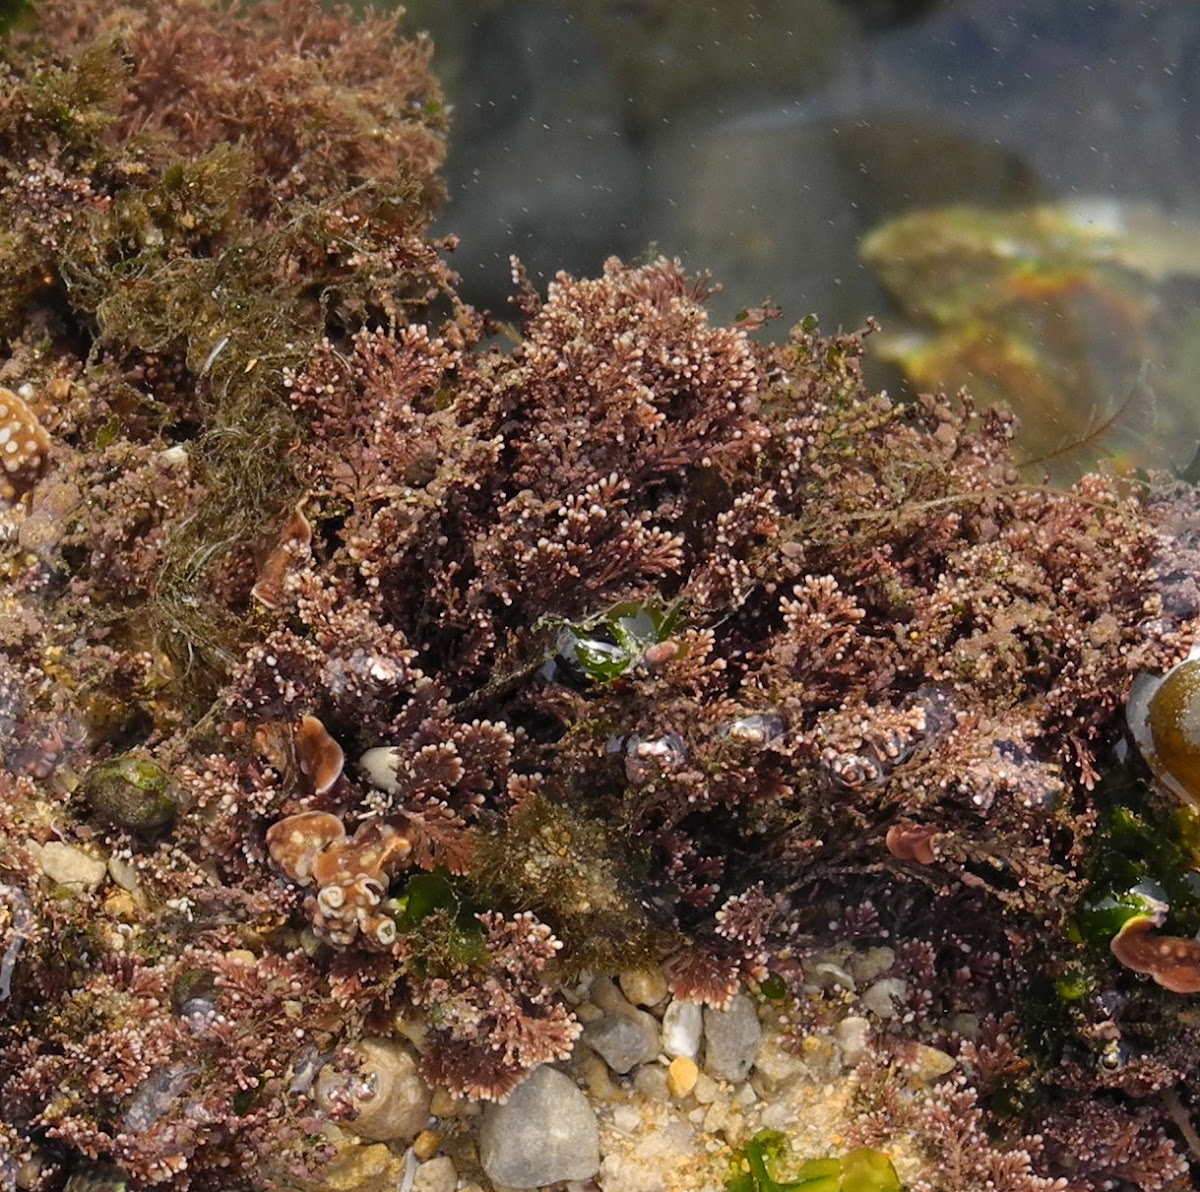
862;199;1200;465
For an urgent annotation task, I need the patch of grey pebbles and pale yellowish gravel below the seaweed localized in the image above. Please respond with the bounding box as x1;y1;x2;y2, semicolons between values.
302;948;955;1192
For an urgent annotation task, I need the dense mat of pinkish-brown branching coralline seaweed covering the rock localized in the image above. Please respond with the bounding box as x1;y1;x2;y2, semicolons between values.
0;0;1200;1192
